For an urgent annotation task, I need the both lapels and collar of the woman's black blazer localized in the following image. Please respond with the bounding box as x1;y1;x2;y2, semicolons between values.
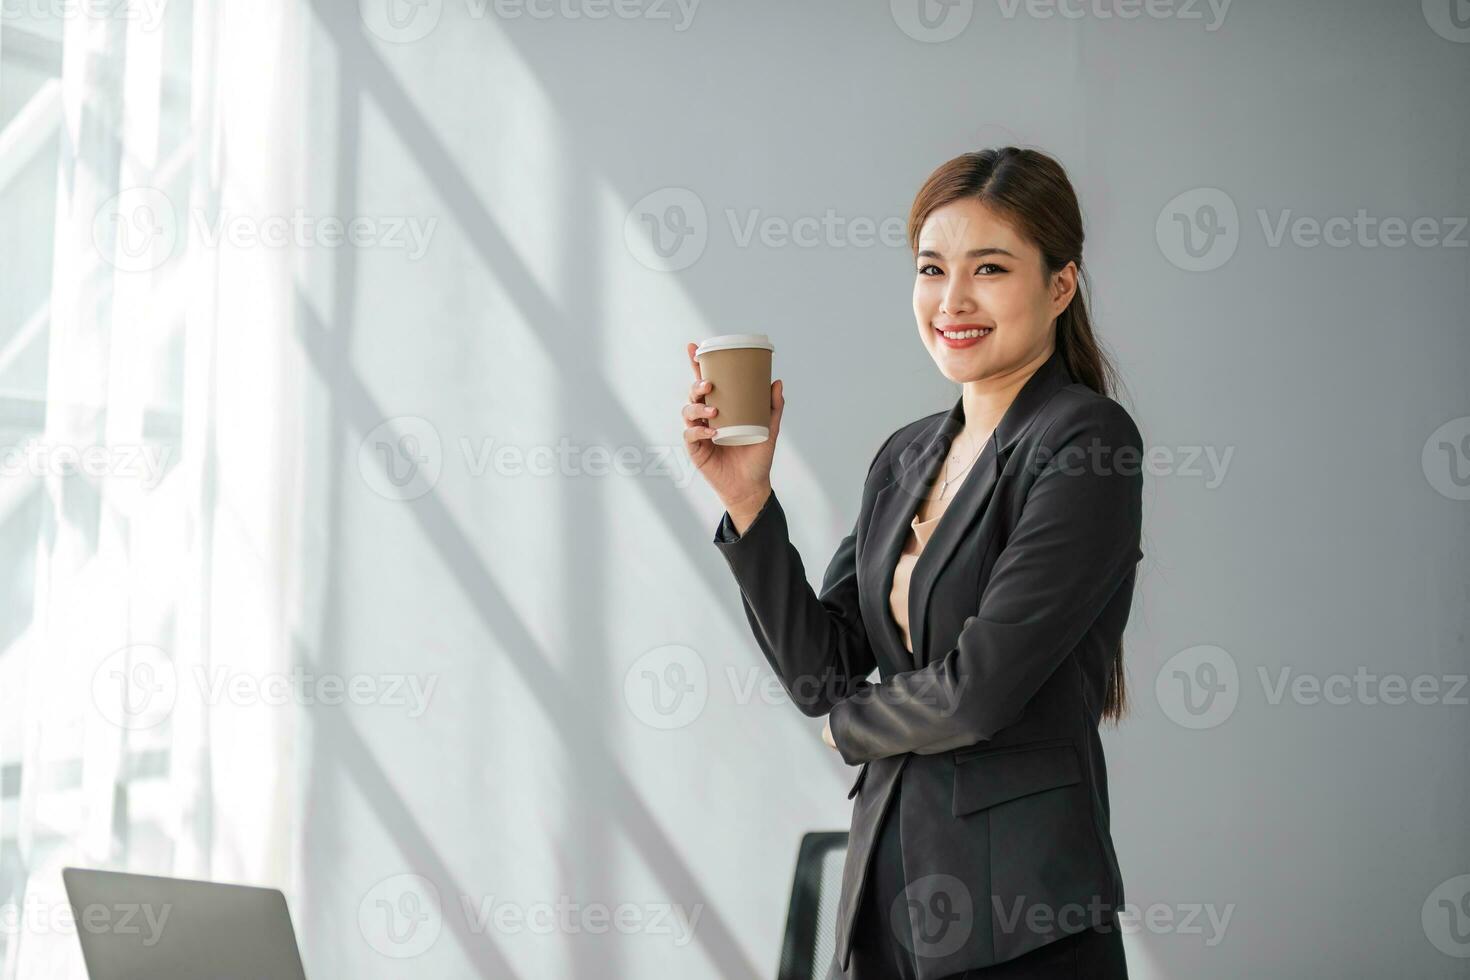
864;340;1073;671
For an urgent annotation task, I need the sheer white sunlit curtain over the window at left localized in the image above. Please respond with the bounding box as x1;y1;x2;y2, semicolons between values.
0;0;301;980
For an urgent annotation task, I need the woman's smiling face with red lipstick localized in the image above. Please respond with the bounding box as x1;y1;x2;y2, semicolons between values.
914;197;1078;383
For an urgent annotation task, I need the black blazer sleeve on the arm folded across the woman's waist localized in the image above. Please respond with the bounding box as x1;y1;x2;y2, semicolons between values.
829;401;1144;764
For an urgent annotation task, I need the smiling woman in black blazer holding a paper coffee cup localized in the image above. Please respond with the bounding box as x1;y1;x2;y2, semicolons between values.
684;147;1142;980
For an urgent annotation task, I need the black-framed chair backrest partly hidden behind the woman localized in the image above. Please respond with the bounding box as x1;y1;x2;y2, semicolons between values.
778;832;847;980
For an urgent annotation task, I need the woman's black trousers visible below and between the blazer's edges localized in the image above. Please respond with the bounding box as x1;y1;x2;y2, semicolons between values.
831;793;1127;980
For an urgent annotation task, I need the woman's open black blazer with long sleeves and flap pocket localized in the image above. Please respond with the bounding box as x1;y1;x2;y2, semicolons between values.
714;350;1142;980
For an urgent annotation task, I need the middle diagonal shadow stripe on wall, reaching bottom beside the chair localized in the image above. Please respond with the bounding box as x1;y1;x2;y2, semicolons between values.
297;294;760;980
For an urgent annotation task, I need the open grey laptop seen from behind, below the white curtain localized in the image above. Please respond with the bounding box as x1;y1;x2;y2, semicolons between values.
62;868;306;980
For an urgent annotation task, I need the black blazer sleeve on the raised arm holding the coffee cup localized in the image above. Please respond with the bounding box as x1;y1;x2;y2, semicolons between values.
714;432;898;717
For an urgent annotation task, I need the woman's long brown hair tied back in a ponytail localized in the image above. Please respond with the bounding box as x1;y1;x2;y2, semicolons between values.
908;147;1127;724
